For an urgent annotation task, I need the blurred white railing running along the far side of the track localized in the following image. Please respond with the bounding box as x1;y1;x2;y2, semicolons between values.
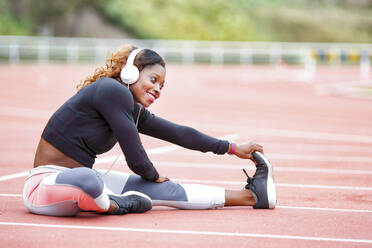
0;36;372;78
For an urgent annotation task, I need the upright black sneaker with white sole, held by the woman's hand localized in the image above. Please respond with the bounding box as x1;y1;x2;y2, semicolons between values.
243;152;276;209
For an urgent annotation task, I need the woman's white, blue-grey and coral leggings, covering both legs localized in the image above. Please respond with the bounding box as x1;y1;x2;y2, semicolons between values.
23;165;225;216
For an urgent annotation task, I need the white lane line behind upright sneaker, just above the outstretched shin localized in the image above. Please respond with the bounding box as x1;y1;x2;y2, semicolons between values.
172;178;372;191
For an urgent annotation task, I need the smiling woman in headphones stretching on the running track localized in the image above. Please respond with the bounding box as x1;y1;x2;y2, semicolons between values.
23;45;276;216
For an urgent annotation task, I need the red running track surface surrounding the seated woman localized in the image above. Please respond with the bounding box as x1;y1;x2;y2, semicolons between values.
0;65;372;248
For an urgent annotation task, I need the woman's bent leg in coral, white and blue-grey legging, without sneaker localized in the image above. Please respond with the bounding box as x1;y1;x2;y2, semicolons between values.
23;168;110;216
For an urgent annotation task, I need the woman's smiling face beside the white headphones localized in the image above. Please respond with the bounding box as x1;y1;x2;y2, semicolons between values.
129;64;165;108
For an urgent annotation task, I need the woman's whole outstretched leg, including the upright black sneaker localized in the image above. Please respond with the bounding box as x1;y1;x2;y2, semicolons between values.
102;152;276;209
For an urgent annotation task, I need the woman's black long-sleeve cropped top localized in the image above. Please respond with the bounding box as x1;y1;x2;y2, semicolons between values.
42;78;229;181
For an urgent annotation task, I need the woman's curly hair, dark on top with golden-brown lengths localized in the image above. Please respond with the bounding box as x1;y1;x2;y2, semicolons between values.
76;45;165;91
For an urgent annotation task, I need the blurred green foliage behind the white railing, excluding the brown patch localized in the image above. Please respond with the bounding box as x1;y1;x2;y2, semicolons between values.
0;0;372;42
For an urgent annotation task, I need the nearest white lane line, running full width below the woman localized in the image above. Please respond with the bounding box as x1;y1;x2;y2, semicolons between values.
0;222;372;244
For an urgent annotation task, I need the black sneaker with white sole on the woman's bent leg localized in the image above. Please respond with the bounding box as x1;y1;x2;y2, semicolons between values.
109;191;152;215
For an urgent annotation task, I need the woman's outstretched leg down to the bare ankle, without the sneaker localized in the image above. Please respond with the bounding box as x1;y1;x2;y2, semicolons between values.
101;171;255;209
